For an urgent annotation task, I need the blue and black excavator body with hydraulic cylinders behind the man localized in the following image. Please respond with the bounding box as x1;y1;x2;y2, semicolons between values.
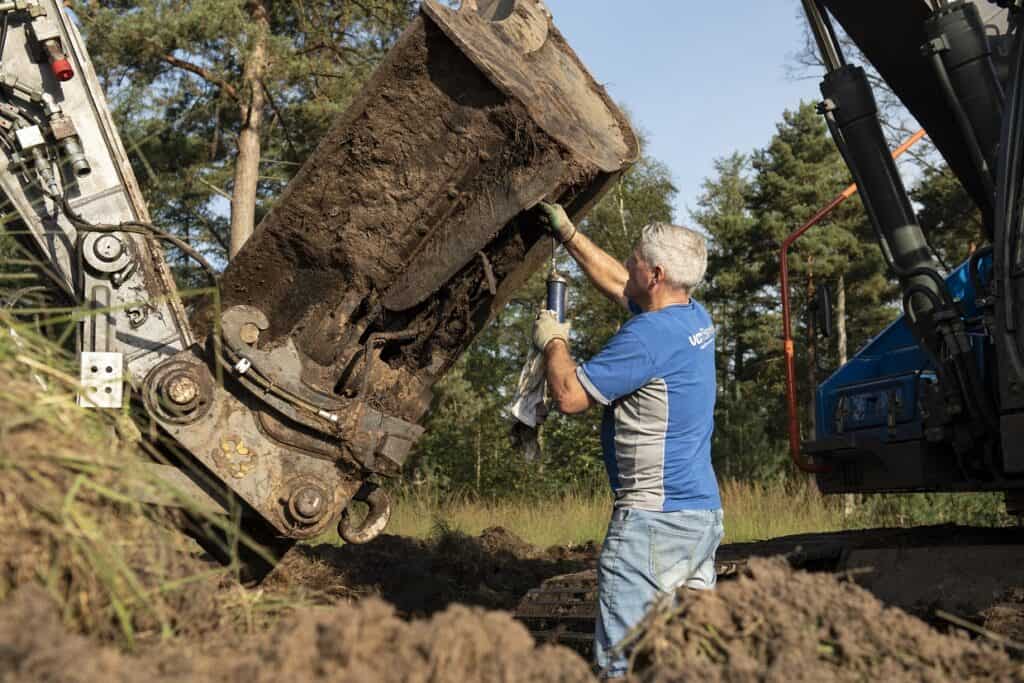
791;0;1024;514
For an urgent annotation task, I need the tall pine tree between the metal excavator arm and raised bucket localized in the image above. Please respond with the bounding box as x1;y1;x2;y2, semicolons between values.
74;0;415;256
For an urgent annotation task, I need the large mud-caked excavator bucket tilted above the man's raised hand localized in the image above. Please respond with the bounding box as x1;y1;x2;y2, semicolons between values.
222;0;638;422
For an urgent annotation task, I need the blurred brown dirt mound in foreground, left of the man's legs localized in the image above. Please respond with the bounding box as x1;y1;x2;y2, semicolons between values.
0;588;593;683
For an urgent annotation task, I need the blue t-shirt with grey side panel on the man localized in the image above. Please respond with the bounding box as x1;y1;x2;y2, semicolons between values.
577;299;722;512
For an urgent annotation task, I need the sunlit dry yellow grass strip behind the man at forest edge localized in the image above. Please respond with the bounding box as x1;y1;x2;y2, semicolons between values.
388;481;845;547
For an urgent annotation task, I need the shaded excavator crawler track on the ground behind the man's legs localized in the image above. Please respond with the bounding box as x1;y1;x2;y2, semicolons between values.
515;524;1024;655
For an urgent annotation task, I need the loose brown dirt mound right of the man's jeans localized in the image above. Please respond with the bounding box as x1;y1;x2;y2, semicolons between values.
631;558;1024;682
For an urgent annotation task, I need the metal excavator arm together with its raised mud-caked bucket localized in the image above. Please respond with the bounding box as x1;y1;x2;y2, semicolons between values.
0;0;638;543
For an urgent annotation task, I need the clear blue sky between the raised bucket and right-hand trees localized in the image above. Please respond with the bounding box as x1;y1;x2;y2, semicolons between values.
546;0;819;222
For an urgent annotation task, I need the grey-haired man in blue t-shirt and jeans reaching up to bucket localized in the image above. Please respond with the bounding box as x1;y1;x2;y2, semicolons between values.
534;204;723;678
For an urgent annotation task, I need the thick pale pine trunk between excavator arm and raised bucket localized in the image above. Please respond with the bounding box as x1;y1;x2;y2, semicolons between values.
229;0;270;258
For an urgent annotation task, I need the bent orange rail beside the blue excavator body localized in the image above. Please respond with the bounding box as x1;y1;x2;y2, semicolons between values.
779;128;926;473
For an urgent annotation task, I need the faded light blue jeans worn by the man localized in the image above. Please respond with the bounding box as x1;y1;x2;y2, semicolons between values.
594;508;724;678
